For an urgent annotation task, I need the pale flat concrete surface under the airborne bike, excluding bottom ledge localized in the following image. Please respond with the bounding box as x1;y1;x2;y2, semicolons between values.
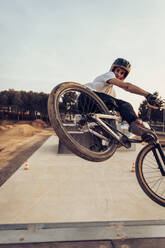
0;135;165;224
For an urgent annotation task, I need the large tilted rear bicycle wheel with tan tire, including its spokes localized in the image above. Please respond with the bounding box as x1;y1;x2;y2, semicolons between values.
48;82;118;162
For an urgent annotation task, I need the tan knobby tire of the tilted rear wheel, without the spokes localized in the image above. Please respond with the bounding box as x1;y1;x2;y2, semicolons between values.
48;82;117;162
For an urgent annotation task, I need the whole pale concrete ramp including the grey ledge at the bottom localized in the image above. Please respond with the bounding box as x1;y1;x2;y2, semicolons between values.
0;135;165;247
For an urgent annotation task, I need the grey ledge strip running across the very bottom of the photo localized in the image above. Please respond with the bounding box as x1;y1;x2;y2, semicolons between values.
0;221;165;248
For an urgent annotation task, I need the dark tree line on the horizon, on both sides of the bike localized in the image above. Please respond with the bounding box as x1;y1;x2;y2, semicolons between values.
0;89;165;126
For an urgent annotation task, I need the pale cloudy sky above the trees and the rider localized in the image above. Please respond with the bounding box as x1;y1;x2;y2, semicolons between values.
0;0;165;110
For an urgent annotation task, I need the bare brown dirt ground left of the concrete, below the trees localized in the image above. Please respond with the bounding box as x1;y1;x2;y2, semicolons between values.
0;119;54;186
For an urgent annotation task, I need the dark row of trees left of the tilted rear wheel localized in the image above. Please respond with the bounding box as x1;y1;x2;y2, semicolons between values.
0;89;49;121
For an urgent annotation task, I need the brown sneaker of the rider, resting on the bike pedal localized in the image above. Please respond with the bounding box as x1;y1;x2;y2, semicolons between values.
129;119;157;140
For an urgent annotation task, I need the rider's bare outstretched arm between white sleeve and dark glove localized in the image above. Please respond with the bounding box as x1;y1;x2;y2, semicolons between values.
107;78;149;97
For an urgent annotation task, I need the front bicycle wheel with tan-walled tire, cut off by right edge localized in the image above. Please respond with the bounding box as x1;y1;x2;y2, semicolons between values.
135;144;165;207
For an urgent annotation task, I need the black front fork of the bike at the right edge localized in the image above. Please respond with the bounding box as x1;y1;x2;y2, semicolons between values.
152;143;165;176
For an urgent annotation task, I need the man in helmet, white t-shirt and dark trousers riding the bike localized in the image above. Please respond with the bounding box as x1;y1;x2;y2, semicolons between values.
85;58;156;139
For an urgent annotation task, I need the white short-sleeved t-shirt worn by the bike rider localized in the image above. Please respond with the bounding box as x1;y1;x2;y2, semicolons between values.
85;71;116;97
